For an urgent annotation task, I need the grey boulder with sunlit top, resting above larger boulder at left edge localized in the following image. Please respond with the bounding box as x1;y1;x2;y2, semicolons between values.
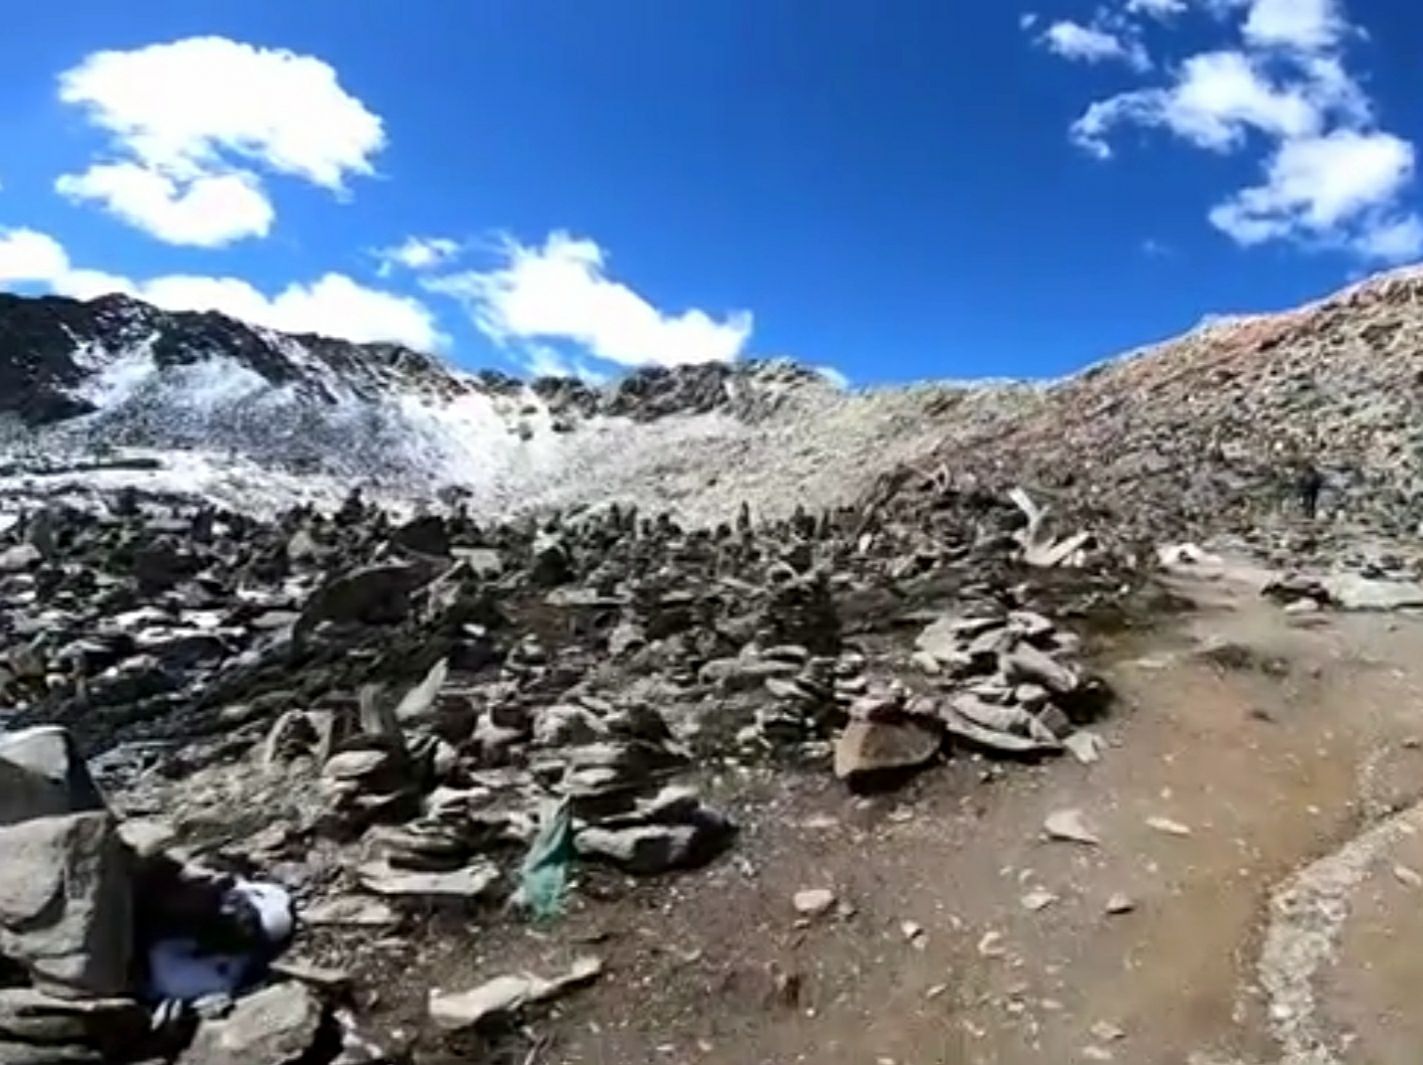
0;725;104;826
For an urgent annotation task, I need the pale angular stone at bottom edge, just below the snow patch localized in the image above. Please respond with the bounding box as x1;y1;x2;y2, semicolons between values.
178;984;326;1065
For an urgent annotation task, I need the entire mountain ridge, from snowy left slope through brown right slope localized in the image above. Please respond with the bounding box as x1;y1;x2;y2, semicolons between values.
13;272;1423;558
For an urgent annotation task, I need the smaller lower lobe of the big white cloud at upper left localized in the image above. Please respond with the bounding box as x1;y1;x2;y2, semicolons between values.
54;162;275;248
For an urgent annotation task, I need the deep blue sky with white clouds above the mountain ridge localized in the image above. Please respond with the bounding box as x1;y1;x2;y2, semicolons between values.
0;0;1423;383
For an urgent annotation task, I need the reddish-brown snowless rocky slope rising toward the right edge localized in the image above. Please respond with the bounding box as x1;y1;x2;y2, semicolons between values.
831;271;1423;575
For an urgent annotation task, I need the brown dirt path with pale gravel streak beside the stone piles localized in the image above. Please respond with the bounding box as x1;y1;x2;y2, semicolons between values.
463;566;1423;1065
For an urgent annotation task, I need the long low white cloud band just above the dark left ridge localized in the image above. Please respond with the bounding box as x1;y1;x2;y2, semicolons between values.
0;229;447;352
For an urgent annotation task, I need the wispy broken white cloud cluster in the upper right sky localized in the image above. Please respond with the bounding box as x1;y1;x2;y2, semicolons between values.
1047;0;1423;262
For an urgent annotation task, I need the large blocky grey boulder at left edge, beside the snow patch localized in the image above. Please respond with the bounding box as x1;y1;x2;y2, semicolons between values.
0;812;134;998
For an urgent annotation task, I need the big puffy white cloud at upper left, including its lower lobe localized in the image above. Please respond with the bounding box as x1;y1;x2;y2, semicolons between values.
55;37;386;246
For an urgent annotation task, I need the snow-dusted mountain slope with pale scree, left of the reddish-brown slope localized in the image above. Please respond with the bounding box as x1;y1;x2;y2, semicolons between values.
0;295;990;520
